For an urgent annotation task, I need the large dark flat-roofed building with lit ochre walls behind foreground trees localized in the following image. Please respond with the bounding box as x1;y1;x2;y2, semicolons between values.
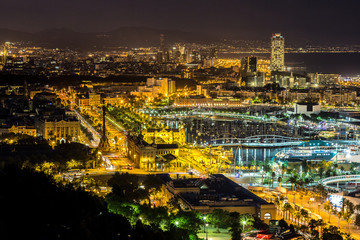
159;174;276;223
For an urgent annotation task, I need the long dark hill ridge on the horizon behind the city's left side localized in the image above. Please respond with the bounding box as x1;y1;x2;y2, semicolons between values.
0;27;220;50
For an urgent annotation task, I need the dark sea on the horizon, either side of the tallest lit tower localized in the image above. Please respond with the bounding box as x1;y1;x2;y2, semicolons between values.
218;53;360;76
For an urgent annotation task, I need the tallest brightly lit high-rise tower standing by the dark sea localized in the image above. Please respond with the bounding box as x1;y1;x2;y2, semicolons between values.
271;33;285;71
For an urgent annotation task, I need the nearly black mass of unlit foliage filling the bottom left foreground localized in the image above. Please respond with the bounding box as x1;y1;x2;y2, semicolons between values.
0;166;191;240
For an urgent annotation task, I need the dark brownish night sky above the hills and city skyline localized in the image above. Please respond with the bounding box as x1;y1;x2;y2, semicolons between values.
0;0;360;43
